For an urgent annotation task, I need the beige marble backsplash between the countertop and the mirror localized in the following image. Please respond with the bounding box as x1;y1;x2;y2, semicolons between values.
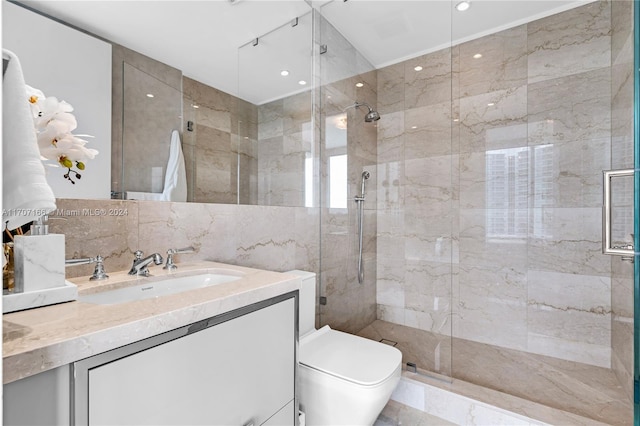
50;199;320;277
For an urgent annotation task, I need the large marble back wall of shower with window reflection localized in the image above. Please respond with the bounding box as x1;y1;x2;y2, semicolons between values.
377;1;615;367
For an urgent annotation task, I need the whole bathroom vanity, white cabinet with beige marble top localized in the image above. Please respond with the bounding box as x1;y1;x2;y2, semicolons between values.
3;262;300;425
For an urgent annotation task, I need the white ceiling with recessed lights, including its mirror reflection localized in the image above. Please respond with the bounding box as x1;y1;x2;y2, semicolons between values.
10;0;593;104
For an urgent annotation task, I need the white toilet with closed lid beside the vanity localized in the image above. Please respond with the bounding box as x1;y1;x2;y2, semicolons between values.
291;271;402;426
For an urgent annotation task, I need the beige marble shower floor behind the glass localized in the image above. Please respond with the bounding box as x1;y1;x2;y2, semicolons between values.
358;320;633;426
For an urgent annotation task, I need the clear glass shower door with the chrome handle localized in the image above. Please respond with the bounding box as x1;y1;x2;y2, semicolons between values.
452;1;638;424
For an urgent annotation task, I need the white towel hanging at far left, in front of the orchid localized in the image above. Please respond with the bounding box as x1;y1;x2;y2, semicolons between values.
2;49;56;229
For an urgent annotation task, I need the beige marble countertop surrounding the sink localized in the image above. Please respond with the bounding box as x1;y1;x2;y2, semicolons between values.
2;262;300;384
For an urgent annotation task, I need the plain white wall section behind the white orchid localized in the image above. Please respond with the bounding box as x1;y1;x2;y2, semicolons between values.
2;1;111;198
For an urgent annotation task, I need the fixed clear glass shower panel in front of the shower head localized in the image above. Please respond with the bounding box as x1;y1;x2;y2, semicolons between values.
316;1;458;380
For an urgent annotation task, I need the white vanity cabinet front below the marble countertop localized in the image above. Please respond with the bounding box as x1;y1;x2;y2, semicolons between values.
72;293;297;426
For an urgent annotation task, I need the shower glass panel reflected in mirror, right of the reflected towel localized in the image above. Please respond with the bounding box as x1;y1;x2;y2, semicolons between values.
237;13;317;207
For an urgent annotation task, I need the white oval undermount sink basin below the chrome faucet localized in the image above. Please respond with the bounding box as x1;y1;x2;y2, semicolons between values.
78;269;243;305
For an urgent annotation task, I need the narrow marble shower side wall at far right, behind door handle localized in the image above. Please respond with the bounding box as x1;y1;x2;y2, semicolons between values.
611;1;637;399
